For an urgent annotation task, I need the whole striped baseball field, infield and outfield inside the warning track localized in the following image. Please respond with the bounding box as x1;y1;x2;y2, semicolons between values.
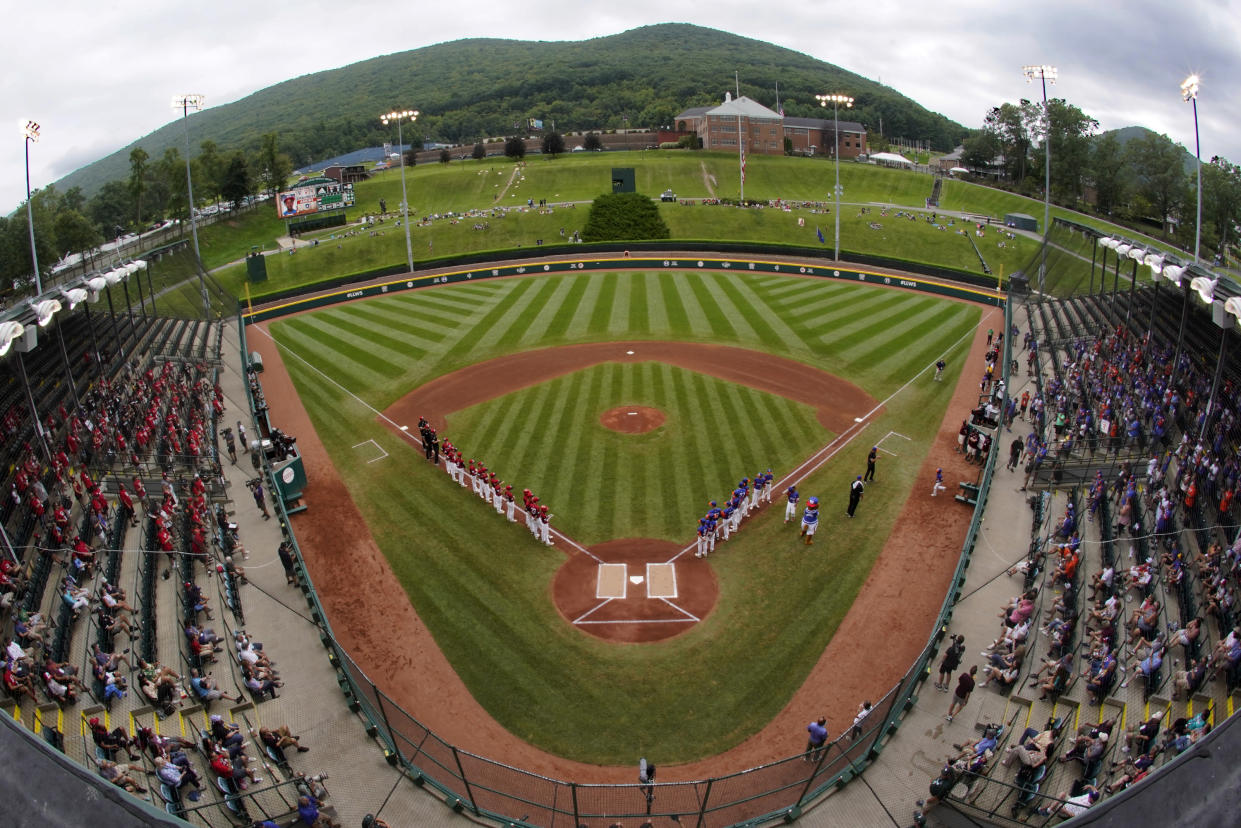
261;265;980;765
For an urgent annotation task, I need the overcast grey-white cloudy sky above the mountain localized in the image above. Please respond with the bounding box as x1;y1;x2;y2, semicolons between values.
0;0;1241;212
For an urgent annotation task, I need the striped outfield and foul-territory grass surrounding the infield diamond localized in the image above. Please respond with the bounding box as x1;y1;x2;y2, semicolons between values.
272;273;980;763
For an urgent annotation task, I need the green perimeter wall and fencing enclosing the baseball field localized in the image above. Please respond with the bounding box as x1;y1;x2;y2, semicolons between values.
238;256;1013;828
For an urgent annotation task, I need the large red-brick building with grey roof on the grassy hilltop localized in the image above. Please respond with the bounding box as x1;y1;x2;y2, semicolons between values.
675;93;867;158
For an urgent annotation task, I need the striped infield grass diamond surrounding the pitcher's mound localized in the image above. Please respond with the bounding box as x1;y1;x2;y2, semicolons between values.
447;362;834;544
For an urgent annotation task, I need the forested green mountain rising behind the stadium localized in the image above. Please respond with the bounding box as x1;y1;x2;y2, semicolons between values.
56;24;967;197
